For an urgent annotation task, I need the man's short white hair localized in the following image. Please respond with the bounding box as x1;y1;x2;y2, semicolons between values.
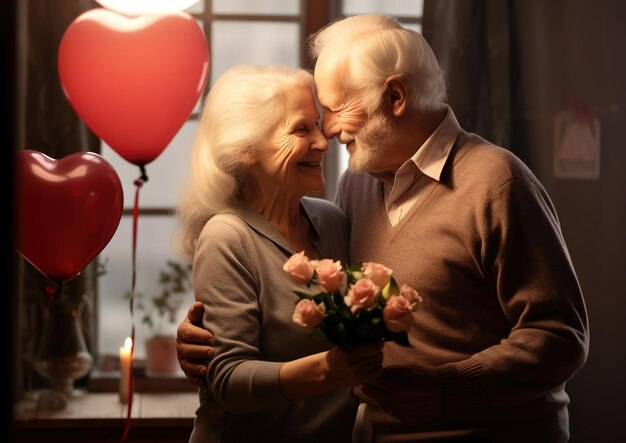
308;14;446;112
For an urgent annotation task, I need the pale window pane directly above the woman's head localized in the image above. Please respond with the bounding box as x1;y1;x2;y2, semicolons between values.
211;20;300;84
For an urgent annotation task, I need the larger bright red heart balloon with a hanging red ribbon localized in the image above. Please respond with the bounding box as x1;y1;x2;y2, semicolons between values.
58;8;209;165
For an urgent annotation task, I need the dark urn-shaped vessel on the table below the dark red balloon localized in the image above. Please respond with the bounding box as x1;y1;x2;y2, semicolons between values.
34;297;93;410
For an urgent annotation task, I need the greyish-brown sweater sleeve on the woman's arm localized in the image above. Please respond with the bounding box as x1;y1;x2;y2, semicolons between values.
194;218;288;413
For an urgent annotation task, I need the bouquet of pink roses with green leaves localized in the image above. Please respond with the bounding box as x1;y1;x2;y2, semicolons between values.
283;251;422;346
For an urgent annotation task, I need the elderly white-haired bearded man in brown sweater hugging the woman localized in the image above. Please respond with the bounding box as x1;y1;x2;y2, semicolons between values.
178;14;588;442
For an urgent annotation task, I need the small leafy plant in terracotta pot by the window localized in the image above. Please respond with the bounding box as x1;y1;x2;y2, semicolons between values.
124;260;192;374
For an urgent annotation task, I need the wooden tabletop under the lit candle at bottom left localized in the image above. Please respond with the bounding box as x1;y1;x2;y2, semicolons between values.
14;392;198;443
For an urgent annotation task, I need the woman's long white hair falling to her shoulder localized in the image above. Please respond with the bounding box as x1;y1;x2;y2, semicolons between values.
173;65;313;261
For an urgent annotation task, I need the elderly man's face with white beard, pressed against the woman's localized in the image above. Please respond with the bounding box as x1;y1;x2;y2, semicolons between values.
315;56;394;173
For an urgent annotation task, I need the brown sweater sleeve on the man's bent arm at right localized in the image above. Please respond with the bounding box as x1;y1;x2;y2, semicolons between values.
438;173;589;412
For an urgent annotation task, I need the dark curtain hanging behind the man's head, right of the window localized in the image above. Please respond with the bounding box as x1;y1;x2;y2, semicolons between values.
423;0;512;148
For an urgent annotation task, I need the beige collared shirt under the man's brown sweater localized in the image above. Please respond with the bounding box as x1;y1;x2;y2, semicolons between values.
384;105;460;226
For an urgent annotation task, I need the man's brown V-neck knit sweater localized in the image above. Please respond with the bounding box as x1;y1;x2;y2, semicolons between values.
336;131;588;442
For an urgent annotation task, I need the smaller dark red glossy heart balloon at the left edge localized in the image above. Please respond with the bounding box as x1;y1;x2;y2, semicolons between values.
15;150;124;284
